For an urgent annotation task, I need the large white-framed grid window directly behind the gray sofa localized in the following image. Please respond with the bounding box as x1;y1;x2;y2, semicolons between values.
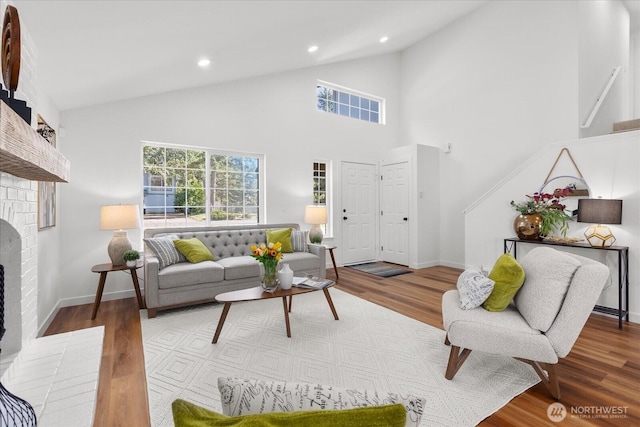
142;143;263;228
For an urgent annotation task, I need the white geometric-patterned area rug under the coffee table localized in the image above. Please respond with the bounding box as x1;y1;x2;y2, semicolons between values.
140;288;539;427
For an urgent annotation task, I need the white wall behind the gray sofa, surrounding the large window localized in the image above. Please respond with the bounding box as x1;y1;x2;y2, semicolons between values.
58;54;399;305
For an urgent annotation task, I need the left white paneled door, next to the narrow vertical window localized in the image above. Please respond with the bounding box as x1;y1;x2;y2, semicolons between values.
340;162;378;264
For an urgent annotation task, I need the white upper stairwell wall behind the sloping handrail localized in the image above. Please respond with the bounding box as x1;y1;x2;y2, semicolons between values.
577;0;633;138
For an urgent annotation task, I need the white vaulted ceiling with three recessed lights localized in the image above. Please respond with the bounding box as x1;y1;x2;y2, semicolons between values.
13;0;485;110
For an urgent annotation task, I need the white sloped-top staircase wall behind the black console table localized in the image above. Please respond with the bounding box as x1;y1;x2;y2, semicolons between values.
465;131;640;323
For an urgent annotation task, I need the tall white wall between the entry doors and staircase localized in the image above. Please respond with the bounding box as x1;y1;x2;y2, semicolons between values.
400;1;578;267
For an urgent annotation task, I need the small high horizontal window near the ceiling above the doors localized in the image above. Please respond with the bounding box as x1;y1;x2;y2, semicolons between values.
316;81;384;124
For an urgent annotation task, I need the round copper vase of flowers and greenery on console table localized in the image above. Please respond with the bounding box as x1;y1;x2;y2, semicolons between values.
511;188;572;240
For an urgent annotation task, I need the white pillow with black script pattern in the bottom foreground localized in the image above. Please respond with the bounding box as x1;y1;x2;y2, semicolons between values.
218;377;425;427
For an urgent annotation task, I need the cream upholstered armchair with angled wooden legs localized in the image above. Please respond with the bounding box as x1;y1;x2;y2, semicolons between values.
442;247;609;399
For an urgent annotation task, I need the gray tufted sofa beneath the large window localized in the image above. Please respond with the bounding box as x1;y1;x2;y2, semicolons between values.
144;224;326;318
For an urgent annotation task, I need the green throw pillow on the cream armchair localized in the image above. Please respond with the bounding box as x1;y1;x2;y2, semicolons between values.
482;254;524;311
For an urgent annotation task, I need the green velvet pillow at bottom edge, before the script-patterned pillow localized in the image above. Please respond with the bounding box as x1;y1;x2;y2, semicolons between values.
171;399;406;427
